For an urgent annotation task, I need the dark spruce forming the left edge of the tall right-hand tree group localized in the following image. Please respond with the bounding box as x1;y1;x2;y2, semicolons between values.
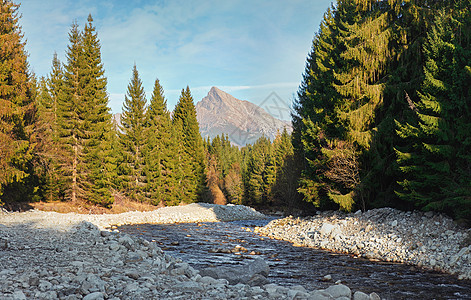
292;1;357;207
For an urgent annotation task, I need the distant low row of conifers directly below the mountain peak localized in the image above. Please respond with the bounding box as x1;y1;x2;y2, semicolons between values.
204;129;300;208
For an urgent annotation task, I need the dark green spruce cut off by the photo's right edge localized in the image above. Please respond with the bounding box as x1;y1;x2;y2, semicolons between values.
396;1;471;218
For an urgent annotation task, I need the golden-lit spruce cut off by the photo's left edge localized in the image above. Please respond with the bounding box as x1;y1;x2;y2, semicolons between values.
0;1;35;203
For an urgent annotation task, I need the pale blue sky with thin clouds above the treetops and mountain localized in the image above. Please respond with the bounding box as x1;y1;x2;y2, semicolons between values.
20;0;331;118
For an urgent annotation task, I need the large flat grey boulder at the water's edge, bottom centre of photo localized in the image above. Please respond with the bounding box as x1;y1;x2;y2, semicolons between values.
200;258;270;285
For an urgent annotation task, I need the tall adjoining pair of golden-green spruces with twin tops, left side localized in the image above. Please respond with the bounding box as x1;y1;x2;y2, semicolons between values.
57;16;114;206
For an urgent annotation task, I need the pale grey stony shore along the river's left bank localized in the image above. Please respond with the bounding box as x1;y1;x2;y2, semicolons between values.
0;204;379;300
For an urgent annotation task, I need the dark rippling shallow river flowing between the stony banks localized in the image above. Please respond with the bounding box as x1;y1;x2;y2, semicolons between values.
119;220;471;299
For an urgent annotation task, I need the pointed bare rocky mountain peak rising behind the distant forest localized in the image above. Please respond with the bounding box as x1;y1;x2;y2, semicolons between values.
196;87;292;146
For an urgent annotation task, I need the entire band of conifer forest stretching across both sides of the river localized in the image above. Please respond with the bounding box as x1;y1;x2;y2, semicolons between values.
0;0;471;222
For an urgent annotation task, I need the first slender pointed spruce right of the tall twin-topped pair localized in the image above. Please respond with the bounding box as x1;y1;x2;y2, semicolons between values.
119;65;148;201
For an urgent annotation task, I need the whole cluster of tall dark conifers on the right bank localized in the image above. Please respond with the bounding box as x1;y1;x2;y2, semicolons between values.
293;0;469;215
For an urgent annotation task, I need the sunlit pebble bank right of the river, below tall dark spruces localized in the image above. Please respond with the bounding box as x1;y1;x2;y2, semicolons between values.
255;208;471;279
